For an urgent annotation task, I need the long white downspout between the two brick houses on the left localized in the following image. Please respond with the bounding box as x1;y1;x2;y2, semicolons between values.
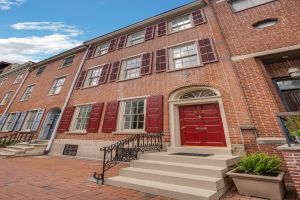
45;45;89;153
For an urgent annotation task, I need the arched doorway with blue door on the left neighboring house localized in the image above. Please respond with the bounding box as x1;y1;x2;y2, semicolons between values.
38;108;61;140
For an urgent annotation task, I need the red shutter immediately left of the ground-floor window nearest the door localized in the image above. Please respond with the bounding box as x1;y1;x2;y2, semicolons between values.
102;101;119;133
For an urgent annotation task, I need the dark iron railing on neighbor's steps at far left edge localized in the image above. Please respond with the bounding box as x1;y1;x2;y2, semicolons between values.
0;132;34;147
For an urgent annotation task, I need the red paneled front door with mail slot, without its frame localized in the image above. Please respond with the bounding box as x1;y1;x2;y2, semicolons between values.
179;103;226;146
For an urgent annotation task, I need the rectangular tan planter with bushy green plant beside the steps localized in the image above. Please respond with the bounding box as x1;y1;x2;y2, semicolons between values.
227;153;285;200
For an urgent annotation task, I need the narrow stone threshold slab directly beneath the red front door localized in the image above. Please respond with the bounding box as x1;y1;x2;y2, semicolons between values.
168;147;232;155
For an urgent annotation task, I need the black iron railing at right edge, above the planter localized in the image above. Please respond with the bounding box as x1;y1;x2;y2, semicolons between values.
277;111;300;147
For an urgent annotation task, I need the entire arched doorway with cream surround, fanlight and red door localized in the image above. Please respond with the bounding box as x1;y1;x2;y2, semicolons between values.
169;87;230;147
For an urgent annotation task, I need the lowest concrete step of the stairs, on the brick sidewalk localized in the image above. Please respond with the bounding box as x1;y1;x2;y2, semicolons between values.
105;176;222;200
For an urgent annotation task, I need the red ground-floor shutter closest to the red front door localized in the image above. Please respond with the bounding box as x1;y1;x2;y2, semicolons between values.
145;96;163;133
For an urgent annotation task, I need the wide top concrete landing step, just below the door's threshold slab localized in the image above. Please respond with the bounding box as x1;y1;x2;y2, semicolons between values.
139;152;240;167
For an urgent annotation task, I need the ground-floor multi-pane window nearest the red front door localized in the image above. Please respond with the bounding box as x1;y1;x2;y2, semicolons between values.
121;99;146;131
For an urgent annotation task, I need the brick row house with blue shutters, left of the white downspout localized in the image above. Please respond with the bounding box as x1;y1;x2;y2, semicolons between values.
0;46;86;140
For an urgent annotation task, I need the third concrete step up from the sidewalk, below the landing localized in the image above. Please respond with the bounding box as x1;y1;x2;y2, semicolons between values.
130;159;228;178
